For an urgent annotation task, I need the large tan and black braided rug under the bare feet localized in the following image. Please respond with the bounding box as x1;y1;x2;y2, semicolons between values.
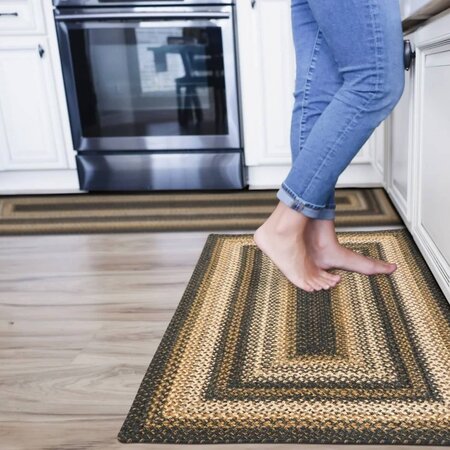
118;229;450;445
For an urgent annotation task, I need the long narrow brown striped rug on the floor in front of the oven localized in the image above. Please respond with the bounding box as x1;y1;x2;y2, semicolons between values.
0;188;402;236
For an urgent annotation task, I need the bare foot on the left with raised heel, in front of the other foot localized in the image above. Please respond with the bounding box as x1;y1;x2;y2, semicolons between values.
253;202;340;292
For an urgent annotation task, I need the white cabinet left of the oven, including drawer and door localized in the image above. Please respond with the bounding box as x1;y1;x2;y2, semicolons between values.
0;0;79;194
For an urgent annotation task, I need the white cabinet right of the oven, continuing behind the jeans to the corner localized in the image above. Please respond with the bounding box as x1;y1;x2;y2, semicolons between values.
236;0;384;189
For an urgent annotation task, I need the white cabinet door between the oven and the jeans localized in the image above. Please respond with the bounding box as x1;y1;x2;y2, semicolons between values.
236;0;295;165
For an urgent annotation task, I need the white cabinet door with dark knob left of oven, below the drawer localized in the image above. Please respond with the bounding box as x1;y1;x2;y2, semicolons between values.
0;38;67;170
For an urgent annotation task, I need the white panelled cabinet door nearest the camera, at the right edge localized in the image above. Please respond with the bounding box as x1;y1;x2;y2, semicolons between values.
412;11;450;299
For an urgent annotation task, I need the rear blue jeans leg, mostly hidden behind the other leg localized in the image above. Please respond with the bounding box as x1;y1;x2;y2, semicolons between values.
279;0;344;218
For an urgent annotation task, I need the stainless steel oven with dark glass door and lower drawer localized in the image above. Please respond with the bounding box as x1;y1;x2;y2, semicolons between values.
54;0;244;190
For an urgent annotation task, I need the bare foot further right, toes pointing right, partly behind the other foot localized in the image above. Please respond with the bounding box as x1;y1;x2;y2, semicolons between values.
305;220;397;275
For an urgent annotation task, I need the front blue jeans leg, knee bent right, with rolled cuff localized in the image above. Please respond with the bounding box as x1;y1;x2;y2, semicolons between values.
279;0;404;218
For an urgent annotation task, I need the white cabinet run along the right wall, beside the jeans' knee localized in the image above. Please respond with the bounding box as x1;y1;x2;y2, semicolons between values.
386;6;450;300
